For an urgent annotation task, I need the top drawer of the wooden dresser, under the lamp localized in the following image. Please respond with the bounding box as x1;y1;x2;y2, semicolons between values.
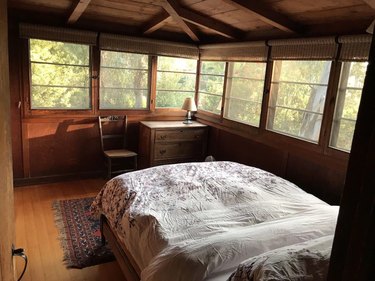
155;129;206;142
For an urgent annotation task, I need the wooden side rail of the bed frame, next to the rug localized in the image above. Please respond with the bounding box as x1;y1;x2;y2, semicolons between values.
100;215;141;281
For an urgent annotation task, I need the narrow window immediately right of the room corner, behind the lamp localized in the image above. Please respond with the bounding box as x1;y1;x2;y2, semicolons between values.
198;61;226;114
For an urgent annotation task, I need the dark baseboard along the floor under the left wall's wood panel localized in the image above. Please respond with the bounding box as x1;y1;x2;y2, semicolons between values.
13;171;106;187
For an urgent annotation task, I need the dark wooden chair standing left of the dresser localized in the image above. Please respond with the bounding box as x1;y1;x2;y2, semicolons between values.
98;115;137;179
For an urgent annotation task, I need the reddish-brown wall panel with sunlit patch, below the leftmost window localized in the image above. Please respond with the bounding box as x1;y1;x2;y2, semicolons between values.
27;118;103;177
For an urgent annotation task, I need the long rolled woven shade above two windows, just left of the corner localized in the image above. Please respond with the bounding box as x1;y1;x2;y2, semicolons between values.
99;33;199;59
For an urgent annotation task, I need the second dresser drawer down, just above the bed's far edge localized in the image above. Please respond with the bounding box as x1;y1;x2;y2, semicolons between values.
154;141;202;160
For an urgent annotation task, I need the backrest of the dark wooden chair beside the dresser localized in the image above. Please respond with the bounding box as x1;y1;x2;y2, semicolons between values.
98;115;128;151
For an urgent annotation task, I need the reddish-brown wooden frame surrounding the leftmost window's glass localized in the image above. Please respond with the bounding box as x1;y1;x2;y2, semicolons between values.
26;38;96;116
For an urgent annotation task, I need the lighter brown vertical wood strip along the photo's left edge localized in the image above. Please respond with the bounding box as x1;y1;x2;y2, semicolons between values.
0;0;14;276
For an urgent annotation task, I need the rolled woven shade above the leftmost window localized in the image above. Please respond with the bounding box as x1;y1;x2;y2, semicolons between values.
19;23;98;45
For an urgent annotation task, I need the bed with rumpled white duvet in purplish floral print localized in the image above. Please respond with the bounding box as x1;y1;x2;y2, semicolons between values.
92;161;338;281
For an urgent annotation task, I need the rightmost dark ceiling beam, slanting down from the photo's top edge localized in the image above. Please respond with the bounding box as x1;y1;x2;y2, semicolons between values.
224;0;302;33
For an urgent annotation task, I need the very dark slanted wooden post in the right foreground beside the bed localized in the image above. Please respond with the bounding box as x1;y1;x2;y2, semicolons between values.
328;31;375;281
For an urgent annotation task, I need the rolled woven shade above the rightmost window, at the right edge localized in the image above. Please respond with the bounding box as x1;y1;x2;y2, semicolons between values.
338;34;372;61
